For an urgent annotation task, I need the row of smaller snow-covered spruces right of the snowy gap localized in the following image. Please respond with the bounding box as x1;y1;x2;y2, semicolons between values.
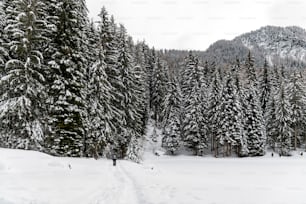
162;52;306;157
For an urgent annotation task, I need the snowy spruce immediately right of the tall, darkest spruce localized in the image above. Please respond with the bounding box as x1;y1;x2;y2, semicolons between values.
85;20;113;157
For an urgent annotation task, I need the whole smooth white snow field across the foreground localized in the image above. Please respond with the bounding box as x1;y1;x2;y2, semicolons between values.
0;149;306;204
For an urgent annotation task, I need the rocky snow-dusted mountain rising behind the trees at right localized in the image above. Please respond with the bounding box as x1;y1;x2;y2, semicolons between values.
203;26;306;66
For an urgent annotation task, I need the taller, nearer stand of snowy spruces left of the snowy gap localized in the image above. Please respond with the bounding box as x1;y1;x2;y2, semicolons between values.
0;0;163;160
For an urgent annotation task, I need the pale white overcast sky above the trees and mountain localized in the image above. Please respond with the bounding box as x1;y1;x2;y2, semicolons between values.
86;0;306;50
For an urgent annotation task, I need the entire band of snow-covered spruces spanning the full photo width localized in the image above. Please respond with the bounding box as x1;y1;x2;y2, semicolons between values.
0;0;306;161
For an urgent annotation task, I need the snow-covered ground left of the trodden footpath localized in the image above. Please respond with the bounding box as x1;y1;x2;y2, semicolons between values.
0;148;142;204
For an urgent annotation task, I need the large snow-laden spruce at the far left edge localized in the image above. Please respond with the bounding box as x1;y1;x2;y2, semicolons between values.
1;0;48;150
